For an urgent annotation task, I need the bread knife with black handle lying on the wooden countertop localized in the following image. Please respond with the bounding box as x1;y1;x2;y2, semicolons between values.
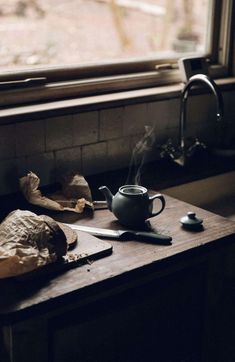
64;224;172;245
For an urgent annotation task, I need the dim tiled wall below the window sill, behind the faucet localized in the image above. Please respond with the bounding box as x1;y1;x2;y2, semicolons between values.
0;91;235;195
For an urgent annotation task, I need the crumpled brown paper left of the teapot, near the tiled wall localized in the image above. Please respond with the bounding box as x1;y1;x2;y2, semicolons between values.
19;171;93;214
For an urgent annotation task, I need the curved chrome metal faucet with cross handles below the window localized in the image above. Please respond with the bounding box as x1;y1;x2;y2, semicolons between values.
160;74;223;166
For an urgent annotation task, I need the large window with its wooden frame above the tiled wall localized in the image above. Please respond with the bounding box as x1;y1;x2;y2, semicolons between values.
0;0;234;105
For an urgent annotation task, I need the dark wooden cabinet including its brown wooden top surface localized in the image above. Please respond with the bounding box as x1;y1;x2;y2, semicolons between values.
0;197;235;362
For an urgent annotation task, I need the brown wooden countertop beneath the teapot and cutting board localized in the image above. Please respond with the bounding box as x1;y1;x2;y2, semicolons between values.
0;196;235;324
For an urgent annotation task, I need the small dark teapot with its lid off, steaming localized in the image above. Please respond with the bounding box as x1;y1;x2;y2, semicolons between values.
99;185;165;227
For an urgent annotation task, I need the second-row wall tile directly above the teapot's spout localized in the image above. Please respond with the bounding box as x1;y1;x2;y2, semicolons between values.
82;142;107;175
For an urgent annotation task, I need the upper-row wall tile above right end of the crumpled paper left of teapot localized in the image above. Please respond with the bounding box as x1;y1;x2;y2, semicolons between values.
73;111;98;146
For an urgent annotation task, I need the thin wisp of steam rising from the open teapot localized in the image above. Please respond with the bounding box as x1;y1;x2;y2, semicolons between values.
126;126;155;185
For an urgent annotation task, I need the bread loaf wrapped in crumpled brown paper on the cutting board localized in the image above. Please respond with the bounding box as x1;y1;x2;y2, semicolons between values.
0;210;67;278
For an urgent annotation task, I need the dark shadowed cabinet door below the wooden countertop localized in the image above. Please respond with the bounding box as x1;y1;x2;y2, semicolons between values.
48;267;206;362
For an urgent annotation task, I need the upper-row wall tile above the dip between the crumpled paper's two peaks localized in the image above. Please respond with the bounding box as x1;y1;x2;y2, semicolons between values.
45;115;73;151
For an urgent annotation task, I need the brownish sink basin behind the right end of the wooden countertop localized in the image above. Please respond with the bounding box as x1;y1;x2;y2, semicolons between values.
161;171;235;220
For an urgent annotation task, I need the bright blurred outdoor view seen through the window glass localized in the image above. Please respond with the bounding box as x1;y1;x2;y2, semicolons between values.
0;0;211;70
